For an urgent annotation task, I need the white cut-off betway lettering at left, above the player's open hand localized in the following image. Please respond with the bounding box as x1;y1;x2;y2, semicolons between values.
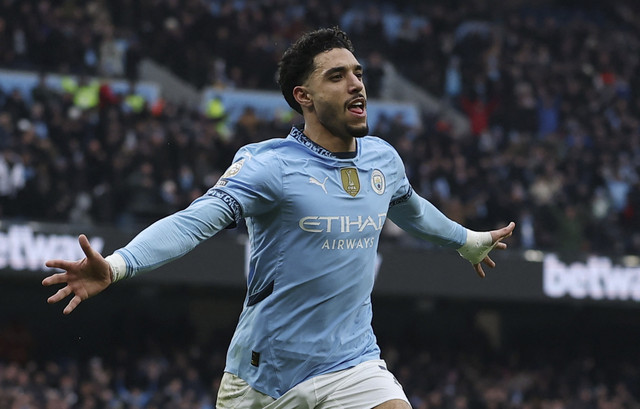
0;225;104;271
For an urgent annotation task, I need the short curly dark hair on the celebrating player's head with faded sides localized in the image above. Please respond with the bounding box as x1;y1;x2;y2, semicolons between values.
278;27;354;114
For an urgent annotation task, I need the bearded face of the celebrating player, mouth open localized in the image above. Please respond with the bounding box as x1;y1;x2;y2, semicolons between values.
304;48;369;138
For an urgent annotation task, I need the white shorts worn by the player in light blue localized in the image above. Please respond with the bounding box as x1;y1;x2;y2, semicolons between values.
216;359;409;409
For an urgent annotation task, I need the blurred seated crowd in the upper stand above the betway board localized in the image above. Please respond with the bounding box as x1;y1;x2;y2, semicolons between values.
0;0;640;254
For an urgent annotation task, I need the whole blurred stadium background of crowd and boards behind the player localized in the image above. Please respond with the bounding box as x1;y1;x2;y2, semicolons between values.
0;0;640;409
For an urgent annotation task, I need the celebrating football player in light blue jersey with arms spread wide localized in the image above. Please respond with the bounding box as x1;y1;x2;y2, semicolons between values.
43;28;514;409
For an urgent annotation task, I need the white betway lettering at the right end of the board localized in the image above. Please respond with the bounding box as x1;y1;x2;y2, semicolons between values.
542;255;640;301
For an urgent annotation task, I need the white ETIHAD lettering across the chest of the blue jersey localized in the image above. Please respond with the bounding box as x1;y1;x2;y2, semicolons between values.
298;213;387;233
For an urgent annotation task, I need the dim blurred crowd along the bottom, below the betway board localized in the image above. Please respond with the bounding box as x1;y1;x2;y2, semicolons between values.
0;330;640;409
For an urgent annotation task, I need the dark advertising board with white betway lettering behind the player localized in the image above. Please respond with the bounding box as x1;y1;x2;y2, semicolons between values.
5;223;640;306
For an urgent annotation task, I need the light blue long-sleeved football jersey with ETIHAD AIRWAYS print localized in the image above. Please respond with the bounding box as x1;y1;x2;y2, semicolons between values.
118;128;466;398
